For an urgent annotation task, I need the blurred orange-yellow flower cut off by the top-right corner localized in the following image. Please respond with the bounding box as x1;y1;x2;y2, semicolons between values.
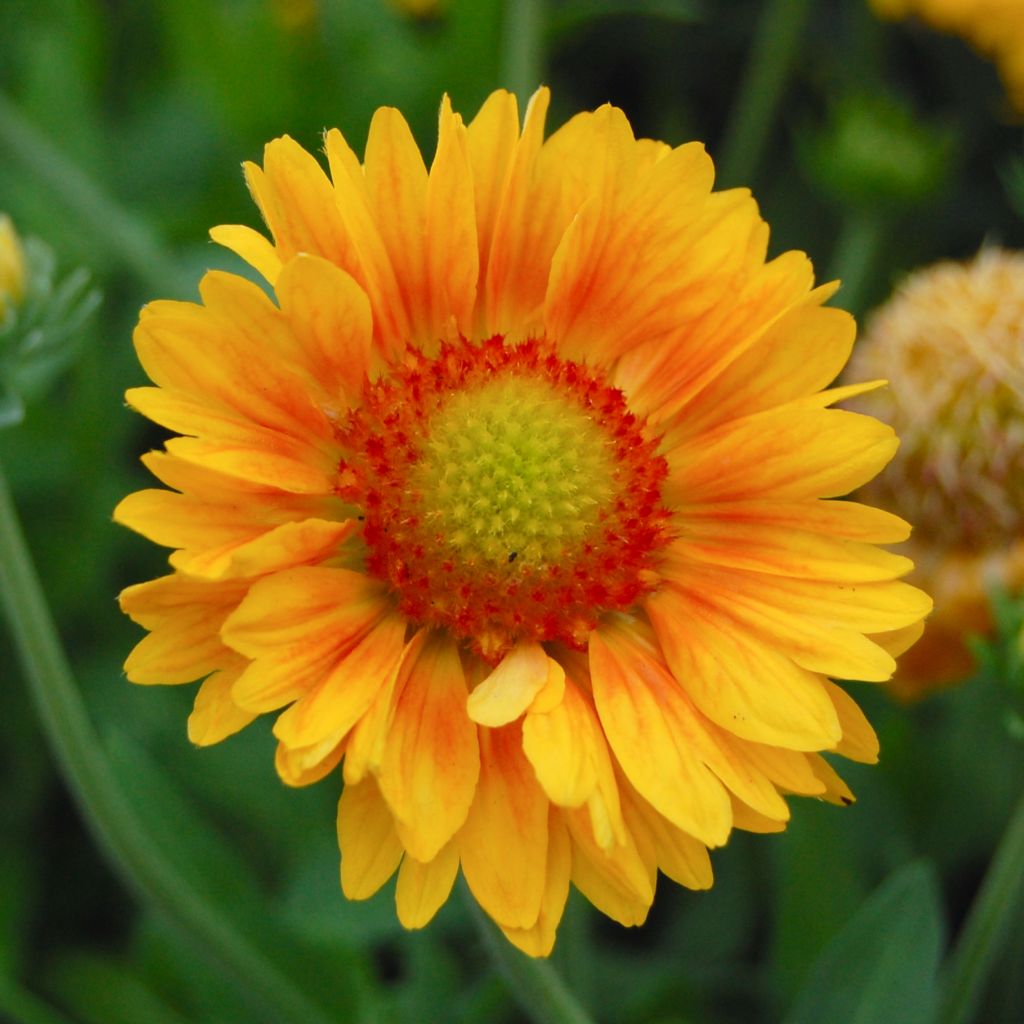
869;0;1024;111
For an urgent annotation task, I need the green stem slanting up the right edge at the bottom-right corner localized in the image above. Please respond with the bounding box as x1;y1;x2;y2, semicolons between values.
935;795;1024;1024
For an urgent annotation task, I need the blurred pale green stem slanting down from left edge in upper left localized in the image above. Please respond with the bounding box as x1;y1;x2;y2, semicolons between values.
0;92;196;298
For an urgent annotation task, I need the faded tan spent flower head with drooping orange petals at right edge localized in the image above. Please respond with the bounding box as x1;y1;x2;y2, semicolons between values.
850;248;1024;697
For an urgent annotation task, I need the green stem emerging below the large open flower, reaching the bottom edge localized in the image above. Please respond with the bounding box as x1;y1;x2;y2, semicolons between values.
460;878;593;1024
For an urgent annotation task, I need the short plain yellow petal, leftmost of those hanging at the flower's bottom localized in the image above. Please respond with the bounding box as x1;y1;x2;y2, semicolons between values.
338;776;404;899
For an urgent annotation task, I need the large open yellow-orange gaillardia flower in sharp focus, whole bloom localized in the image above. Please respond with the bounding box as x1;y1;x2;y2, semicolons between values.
117;90;930;955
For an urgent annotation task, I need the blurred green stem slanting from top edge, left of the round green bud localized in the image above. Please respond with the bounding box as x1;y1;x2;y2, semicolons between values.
718;0;813;188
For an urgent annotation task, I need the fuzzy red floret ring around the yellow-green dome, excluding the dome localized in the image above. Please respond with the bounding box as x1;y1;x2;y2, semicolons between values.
338;336;671;663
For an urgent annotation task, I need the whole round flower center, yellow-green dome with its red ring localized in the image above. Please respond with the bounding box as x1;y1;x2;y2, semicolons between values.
339;338;670;662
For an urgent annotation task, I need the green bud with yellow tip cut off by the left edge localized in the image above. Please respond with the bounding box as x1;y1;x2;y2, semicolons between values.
0;214;100;427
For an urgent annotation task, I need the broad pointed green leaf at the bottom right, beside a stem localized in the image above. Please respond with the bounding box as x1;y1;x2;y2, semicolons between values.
785;861;944;1024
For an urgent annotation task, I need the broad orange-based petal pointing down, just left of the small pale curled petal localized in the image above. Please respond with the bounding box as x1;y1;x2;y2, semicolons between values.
378;633;480;863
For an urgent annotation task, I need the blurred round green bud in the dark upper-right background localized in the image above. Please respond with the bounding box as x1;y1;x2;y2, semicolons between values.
799;95;951;206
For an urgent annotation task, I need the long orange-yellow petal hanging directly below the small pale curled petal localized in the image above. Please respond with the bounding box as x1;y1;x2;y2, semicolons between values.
459;723;548;928
